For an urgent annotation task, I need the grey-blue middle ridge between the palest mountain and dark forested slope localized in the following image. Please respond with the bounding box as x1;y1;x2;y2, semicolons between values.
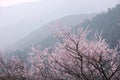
12;14;95;49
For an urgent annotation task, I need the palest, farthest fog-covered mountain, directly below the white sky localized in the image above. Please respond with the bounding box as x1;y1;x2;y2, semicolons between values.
0;0;119;48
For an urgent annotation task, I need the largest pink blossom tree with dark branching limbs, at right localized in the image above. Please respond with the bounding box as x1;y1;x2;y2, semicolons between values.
49;28;120;80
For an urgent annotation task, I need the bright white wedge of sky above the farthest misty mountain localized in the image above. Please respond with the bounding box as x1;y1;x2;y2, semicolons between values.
0;0;38;7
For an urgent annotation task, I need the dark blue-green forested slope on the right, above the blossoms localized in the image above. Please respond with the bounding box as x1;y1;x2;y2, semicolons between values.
81;5;120;47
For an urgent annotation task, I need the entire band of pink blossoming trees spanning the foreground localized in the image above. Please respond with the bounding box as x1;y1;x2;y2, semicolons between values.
0;27;120;80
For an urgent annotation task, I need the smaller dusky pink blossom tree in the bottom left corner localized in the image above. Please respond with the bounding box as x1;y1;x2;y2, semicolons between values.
0;53;29;80
